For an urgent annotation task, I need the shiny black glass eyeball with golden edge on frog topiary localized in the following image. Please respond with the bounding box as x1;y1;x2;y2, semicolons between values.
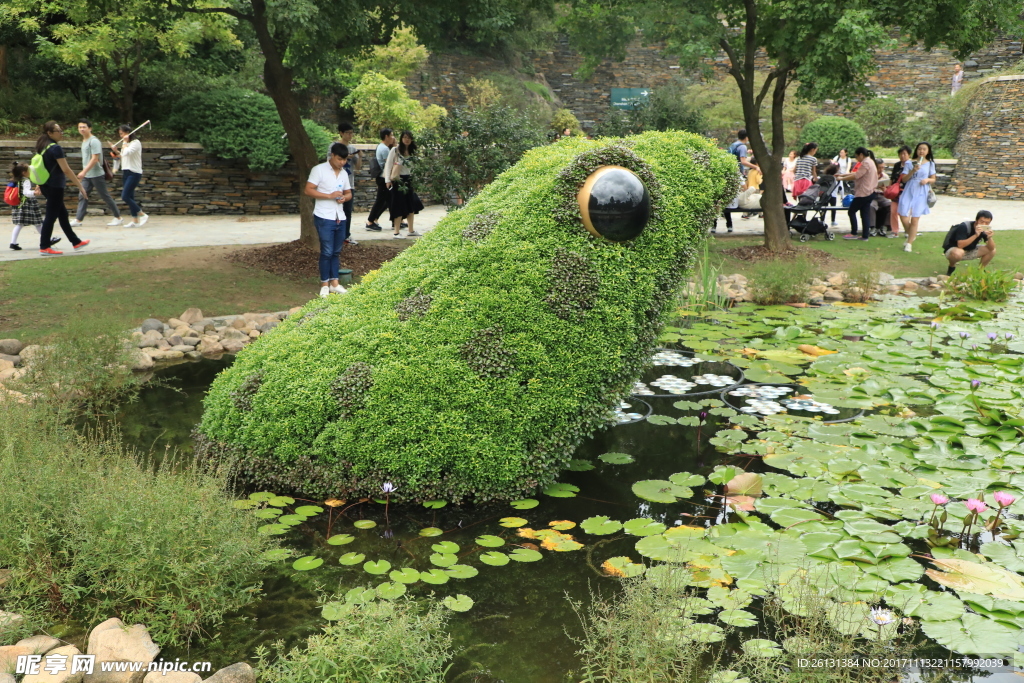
577;166;650;242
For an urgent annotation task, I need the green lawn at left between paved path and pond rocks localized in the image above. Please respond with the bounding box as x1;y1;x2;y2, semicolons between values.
0;247;318;343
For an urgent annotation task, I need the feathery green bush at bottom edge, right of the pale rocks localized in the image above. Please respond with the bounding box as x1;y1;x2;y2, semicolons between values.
257;600;453;683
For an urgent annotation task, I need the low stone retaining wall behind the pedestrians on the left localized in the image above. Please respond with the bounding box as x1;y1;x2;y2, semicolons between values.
0;140;385;215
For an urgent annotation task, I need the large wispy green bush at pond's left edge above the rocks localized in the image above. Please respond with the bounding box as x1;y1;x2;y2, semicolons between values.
0;400;272;645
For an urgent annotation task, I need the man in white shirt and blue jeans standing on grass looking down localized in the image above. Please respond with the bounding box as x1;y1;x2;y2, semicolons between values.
305;142;352;298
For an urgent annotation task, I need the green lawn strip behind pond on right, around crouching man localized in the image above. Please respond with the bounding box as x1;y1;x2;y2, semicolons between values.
711;230;1024;278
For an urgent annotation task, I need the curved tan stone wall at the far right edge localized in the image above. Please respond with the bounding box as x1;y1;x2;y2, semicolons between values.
947;76;1024;200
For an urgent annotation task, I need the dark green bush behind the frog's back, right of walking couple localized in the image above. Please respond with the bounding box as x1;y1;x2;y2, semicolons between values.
416;106;545;204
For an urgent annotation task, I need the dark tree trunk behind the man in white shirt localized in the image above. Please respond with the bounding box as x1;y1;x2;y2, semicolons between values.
249;0;319;251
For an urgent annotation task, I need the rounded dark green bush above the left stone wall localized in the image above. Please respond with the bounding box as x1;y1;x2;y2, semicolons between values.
167;88;330;171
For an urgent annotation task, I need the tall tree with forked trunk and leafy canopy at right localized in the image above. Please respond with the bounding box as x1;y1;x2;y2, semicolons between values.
564;0;1022;252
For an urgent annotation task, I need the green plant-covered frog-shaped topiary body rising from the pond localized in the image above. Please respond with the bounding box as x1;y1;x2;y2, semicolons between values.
198;132;736;501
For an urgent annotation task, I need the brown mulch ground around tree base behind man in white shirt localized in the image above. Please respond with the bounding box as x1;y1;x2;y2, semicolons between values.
224;240;409;280
